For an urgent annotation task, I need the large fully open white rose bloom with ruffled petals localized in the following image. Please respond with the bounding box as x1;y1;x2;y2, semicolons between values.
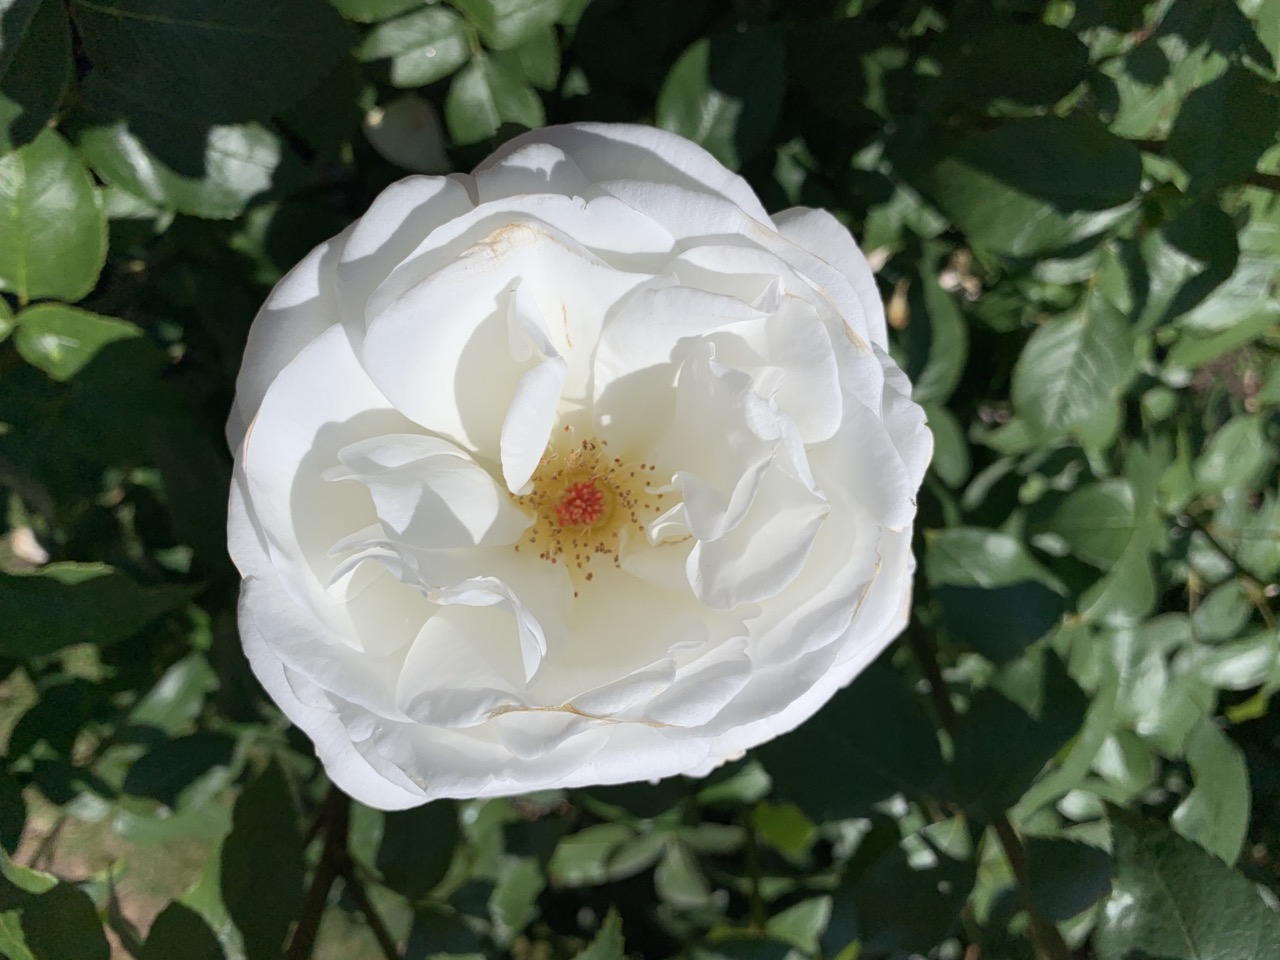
228;124;932;809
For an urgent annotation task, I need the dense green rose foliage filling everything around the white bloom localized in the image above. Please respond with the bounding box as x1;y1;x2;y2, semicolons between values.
0;0;1280;960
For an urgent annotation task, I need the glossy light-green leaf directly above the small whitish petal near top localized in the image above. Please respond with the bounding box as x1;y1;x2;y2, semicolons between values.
357;6;471;87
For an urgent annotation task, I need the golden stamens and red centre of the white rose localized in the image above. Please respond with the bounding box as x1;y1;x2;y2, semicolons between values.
515;428;669;586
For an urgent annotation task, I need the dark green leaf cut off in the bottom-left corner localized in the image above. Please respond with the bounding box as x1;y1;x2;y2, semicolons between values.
0;852;111;960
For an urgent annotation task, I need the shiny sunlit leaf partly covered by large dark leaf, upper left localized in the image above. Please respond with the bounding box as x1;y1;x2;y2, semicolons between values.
81;123;283;219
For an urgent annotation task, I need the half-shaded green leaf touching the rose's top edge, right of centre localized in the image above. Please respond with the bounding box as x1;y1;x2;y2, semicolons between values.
657;28;786;170
